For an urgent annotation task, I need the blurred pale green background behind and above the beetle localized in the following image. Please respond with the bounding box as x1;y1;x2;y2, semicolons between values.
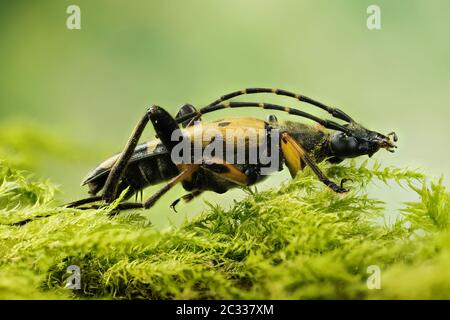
0;0;450;228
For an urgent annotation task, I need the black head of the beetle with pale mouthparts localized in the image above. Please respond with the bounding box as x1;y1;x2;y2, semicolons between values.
330;122;398;161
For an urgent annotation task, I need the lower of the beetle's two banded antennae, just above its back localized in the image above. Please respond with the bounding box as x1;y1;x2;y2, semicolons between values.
175;102;351;135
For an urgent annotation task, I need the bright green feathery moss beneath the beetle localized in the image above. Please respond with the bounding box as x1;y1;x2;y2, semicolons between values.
0;162;450;299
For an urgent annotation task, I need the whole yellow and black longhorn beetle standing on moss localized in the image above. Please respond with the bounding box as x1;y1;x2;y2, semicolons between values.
67;88;397;210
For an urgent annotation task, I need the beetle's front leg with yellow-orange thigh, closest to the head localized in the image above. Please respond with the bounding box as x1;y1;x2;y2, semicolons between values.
281;132;349;193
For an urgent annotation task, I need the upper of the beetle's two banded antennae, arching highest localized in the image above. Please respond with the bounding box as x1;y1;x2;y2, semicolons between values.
206;88;353;122
